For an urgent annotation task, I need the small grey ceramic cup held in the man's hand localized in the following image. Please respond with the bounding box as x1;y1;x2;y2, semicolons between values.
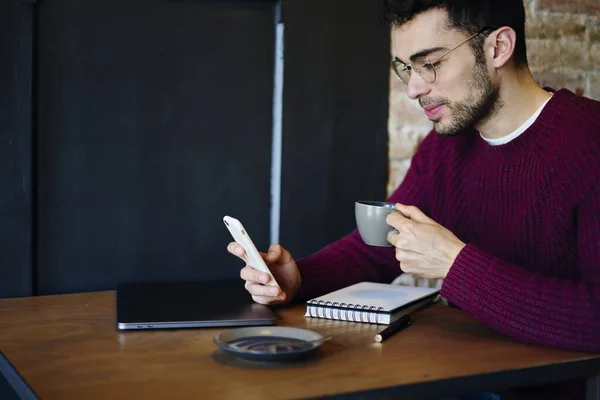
354;201;400;247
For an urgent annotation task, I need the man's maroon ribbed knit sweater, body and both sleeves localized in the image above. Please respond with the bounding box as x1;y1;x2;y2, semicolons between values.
298;89;600;352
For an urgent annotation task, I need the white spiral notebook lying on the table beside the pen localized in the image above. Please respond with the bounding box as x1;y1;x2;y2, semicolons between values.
304;282;440;325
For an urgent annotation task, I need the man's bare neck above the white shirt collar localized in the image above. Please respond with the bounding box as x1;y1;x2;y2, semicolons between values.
476;69;551;139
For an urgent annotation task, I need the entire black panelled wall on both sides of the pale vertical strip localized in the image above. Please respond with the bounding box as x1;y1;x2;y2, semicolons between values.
0;0;389;297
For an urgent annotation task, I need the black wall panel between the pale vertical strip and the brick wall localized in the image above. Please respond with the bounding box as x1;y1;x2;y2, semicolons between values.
280;0;390;257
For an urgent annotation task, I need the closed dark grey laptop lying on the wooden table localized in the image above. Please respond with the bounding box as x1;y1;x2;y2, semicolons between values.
117;279;277;330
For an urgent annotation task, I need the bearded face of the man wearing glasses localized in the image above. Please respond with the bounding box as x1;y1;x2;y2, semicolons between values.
393;9;501;136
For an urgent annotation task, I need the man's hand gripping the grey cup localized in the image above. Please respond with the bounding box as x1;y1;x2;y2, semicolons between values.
386;203;465;279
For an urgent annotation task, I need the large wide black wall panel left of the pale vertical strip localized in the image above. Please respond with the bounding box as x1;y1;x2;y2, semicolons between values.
37;0;274;294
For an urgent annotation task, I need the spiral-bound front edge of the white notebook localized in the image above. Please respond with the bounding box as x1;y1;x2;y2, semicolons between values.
307;300;384;324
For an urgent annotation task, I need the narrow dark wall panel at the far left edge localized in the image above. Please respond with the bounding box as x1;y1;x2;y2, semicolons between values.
0;0;33;297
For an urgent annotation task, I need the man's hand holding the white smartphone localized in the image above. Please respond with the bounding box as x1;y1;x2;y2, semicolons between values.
227;242;302;304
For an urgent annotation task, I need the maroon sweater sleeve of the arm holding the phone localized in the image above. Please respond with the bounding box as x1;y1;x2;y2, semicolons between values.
296;133;432;300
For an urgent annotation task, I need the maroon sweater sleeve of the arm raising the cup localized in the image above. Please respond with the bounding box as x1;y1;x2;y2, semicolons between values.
441;189;600;352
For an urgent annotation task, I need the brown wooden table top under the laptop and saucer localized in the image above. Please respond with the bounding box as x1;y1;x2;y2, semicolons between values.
0;292;600;400
